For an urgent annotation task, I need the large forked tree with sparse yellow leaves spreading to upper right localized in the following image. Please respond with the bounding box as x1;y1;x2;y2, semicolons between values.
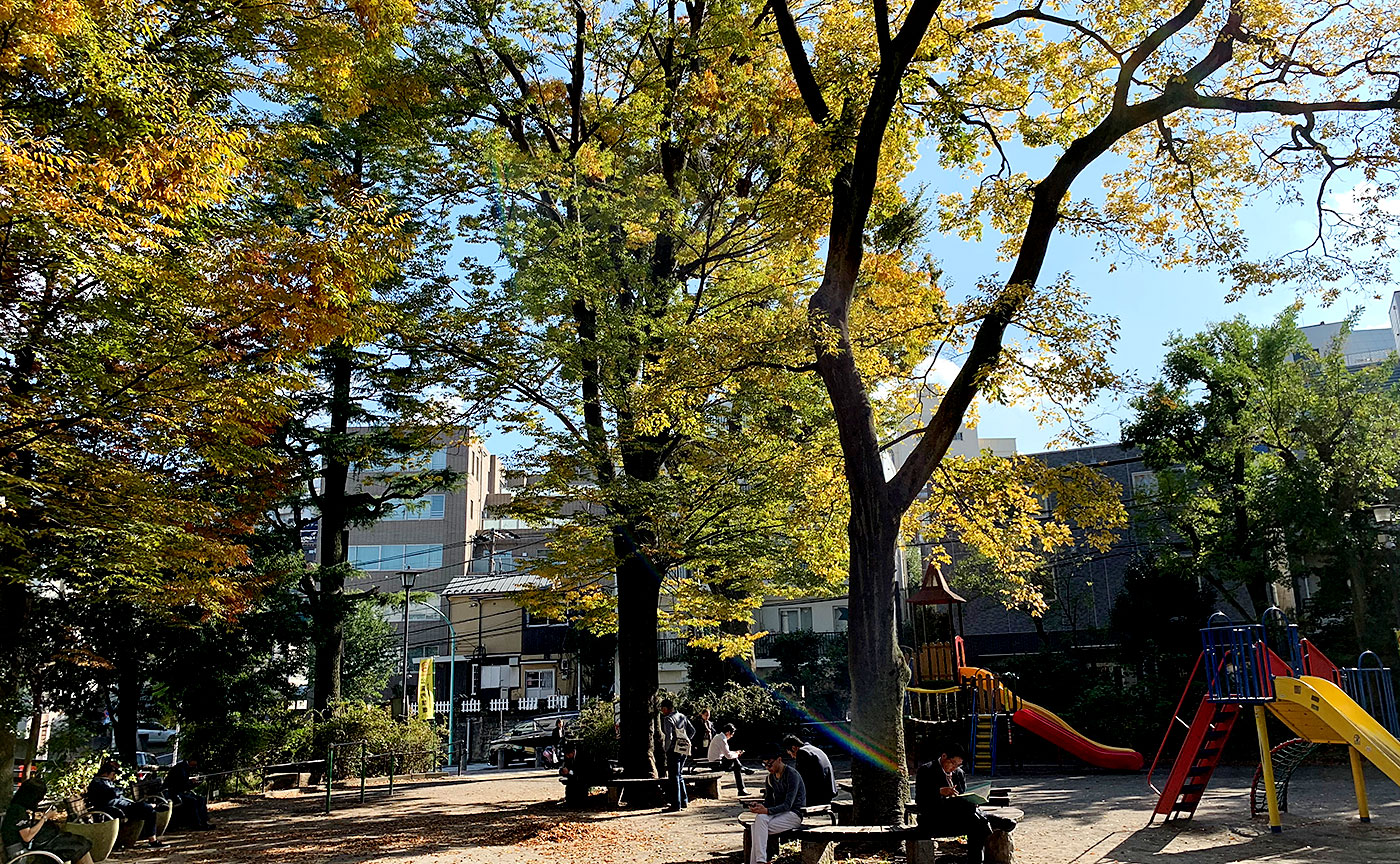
767;0;1400;822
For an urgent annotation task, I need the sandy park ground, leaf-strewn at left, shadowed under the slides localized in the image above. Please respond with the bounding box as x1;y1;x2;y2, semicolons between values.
116;762;1400;864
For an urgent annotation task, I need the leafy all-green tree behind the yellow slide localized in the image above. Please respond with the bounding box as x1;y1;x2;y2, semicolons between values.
1123;309;1400;647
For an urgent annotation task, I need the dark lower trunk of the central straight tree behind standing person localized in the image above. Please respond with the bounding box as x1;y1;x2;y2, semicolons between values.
613;515;661;777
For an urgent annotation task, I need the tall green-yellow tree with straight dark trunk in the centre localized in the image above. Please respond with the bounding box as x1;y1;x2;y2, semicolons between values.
437;3;840;776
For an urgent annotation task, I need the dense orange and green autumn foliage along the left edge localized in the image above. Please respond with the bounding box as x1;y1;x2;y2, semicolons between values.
0;0;403;798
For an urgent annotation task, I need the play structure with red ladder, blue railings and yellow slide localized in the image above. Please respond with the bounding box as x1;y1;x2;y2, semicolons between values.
1148;608;1400;833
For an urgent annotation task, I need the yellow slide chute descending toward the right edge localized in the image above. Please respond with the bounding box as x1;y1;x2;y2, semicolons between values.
1268;675;1400;786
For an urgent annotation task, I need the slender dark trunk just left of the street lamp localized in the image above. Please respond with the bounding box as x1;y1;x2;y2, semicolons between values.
311;339;355;711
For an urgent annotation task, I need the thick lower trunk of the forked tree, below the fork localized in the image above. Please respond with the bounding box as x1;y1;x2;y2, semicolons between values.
847;498;909;825
